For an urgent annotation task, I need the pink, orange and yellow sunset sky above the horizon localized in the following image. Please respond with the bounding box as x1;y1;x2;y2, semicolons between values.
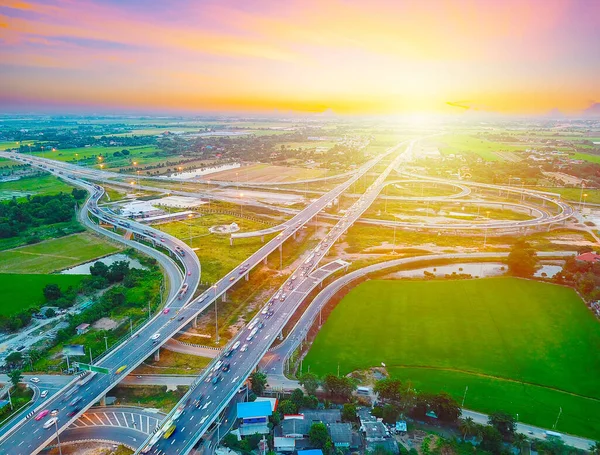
0;0;600;115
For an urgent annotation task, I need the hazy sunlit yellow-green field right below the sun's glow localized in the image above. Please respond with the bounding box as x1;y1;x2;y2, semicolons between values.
427;134;527;161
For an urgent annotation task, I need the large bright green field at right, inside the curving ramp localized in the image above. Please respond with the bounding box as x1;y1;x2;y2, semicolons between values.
304;278;600;438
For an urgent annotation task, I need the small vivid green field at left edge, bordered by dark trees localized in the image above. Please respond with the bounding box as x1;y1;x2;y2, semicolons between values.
0;273;83;316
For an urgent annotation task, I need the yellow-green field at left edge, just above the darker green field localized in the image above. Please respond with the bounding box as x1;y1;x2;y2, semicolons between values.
0;232;119;273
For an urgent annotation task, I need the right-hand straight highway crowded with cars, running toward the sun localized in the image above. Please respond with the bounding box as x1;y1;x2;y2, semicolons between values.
138;141;414;454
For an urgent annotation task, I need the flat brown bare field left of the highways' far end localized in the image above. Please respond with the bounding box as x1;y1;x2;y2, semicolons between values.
206;163;327;183
